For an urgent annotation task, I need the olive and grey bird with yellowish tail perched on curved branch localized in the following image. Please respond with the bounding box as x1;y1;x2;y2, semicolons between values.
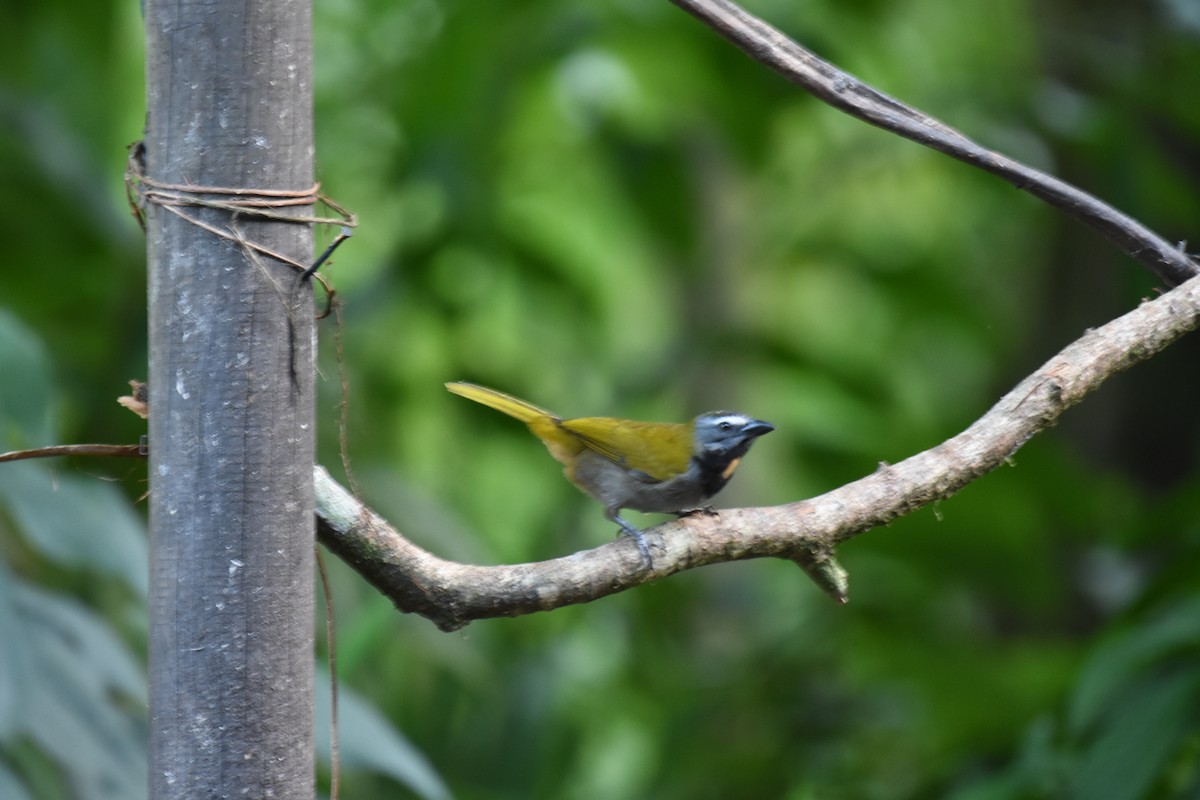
445;381;775;569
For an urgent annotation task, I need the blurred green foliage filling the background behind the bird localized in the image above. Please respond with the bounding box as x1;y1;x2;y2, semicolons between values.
0;0;1200;800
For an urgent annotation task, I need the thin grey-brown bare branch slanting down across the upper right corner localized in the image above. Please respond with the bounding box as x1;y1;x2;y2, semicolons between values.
671;0;1200;287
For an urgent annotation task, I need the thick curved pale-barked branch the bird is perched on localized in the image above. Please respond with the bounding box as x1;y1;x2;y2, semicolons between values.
316;277;1200;630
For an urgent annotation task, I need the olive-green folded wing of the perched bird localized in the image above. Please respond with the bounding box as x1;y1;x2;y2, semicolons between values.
559;416;692;481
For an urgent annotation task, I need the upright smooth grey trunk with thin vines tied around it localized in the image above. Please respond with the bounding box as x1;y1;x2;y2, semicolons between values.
145;0;314;800
